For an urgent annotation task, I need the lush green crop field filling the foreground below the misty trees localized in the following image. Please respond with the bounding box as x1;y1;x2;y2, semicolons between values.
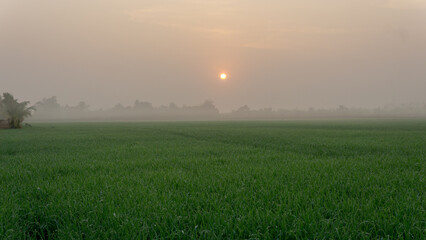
0;120;426;239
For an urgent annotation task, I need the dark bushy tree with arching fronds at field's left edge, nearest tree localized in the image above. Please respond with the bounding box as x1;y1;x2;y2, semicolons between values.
0;93;35;128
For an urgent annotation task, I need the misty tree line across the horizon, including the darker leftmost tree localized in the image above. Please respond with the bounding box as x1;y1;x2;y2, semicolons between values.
0;93;426;128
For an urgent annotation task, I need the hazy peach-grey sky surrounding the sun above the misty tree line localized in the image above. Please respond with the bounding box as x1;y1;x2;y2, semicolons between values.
0;0;426;111
